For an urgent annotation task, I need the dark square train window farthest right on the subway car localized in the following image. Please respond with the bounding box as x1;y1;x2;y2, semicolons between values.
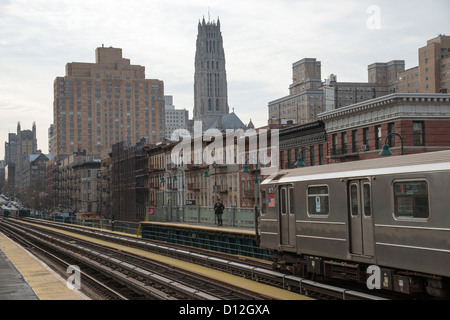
394;181;430;219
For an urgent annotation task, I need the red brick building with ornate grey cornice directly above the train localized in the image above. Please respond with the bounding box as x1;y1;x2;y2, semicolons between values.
319;94;450;163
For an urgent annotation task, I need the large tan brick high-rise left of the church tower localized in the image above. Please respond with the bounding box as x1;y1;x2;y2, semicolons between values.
51;47;165;160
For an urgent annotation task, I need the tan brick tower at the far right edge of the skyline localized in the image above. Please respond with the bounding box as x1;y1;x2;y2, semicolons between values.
399;35;450;93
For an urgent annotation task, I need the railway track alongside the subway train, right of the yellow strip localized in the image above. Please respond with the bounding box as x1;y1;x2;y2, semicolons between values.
1;220;383;300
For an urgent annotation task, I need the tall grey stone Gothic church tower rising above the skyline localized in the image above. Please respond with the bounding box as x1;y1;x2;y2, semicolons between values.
194;18;229;130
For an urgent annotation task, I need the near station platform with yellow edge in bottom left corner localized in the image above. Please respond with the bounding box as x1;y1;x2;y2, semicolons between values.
0;233;89;300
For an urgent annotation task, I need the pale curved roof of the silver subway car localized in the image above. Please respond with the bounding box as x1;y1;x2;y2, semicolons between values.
262;150;450;185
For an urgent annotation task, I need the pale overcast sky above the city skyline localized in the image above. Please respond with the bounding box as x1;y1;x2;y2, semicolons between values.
0;0;450;159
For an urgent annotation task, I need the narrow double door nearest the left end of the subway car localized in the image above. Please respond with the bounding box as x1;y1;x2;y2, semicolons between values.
278;186;296;247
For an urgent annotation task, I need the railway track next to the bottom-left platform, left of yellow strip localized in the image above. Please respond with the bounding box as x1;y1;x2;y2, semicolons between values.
0;220;267;300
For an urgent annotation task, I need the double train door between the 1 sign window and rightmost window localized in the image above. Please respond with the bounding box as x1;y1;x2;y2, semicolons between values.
348;179;374;257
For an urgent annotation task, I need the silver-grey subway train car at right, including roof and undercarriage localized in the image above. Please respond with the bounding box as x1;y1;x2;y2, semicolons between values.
260;151;450;298
